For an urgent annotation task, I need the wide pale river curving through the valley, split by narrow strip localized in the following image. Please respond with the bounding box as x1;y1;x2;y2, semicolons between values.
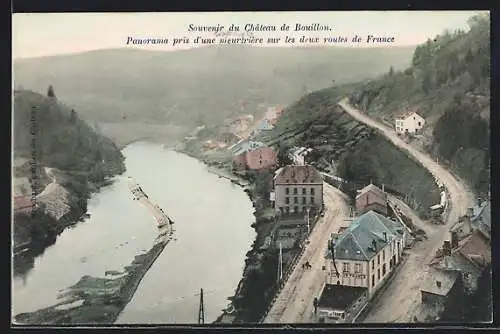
12;142;255;324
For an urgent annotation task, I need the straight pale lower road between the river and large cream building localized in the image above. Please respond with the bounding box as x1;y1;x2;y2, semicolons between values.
264;183;349;323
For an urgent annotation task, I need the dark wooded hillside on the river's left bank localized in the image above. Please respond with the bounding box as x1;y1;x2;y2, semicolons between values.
13;87;125;260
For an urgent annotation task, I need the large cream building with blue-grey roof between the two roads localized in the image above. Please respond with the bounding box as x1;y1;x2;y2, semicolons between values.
325;211;407;297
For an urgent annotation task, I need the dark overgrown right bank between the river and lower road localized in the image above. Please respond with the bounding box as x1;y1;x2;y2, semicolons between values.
176;148;278;324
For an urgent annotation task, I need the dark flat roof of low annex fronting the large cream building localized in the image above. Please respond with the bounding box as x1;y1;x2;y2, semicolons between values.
318;284;368;310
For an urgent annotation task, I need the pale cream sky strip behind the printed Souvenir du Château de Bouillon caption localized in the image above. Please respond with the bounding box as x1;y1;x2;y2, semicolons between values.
12;11;486;59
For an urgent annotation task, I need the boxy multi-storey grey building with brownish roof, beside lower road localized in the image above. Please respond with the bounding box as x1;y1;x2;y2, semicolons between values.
274;165;323;214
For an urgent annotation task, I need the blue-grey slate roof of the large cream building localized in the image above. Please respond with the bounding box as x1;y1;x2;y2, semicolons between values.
326;210;403;261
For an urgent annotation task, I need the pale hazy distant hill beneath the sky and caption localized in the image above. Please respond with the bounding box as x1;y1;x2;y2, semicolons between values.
14;46;414;144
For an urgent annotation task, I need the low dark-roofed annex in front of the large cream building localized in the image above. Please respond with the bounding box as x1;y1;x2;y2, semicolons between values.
315;284;368;323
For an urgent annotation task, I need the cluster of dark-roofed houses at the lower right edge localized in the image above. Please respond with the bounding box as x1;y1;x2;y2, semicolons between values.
421;201;491;316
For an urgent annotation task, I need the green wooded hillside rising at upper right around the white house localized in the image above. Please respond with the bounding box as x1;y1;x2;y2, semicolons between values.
268;16;490;200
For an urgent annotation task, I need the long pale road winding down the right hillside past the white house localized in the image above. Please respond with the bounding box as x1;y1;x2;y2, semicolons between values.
338;98;474;323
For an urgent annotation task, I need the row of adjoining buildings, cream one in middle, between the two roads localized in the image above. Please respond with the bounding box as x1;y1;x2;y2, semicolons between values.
315;184;409;323
